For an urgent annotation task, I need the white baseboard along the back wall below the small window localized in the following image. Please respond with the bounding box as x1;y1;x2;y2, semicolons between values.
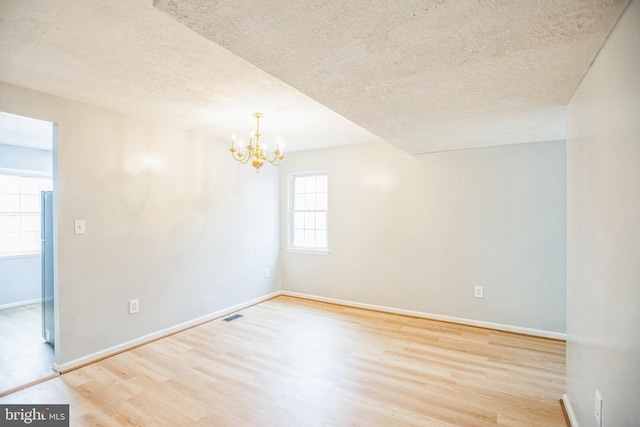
282;291;567;341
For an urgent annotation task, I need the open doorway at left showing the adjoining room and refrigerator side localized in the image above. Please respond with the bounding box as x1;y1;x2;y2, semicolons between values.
0;112;56;396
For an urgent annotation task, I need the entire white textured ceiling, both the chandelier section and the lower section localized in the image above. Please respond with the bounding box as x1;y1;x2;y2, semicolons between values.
0;0;627;153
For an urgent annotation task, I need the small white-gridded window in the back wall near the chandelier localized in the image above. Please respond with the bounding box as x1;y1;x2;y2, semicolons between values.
289;172;329;251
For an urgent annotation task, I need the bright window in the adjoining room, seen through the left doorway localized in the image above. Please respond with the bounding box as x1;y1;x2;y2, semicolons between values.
0;174;53;254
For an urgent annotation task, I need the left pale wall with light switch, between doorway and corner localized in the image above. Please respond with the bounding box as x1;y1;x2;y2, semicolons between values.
0;83;280;364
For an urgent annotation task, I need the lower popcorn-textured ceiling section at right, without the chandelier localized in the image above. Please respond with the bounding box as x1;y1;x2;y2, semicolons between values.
156;0;625;153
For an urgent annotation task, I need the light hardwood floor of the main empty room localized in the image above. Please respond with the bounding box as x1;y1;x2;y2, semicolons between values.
0;296;566;426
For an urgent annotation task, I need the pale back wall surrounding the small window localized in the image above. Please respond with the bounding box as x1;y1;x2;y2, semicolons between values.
280;141;566;333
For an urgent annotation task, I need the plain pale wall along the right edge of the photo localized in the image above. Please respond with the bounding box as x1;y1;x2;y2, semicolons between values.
567;0;640;427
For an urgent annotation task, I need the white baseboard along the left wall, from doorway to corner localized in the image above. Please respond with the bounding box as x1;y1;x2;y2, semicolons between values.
53;291;280;373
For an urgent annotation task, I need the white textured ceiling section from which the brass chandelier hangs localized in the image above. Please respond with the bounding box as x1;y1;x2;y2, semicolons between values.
0;0;380;154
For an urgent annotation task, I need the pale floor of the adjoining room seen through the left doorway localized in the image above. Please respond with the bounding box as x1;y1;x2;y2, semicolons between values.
0;303;55;395
